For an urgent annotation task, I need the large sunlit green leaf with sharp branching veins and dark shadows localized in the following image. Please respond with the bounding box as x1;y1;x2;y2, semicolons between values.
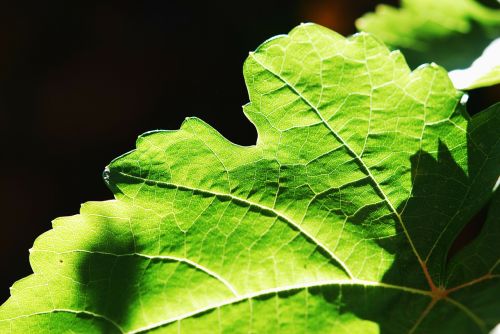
0;24;500;333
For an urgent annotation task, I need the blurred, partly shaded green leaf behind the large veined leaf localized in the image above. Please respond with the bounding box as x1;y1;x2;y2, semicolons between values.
356;0;500;89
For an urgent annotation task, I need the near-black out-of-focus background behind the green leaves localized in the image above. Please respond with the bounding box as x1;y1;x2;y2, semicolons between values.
0;0;500;304
